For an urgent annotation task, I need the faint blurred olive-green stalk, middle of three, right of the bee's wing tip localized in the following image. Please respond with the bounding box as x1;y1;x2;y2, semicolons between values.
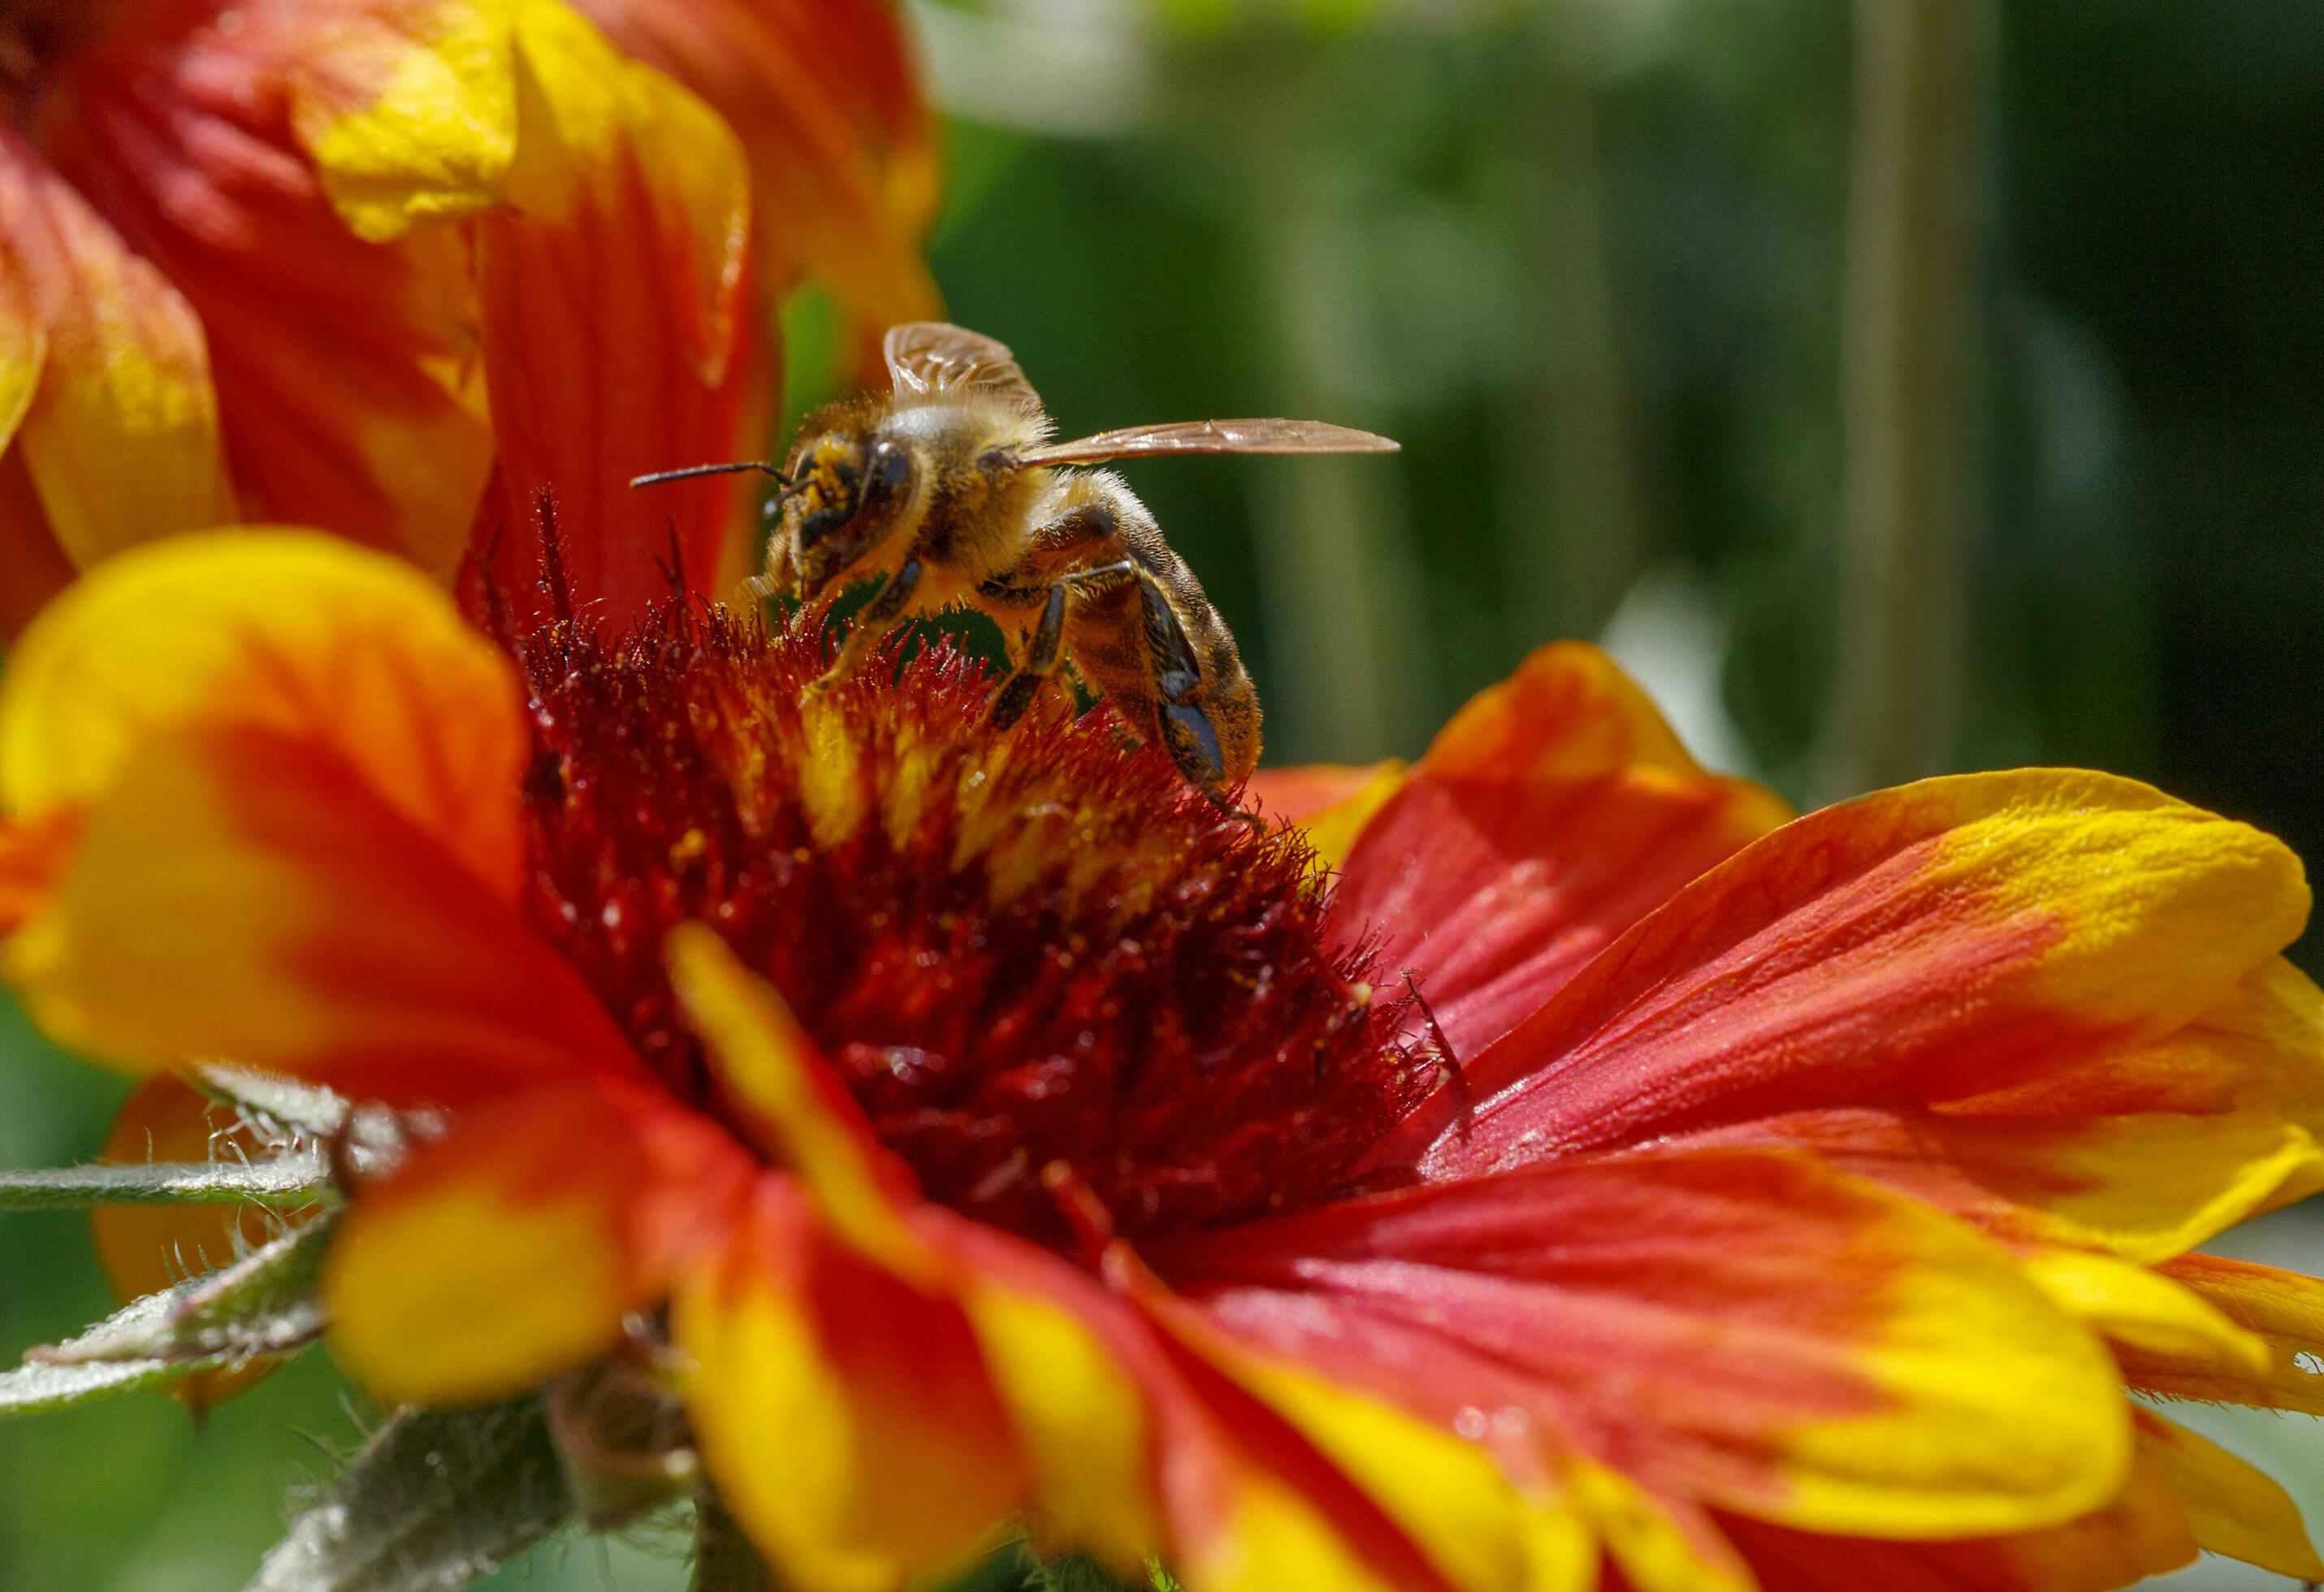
1495;32;1646;653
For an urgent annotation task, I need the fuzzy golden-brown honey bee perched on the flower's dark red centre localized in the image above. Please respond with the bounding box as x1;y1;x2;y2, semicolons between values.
632;321;1396;802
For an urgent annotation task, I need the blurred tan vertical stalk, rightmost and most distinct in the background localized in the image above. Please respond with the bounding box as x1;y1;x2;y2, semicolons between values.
1817;0;1989;797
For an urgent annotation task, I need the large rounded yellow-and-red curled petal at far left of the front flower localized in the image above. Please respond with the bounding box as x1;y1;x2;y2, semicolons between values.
0;532;639;1104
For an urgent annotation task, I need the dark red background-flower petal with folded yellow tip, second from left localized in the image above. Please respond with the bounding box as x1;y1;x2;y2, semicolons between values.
41;0;513;577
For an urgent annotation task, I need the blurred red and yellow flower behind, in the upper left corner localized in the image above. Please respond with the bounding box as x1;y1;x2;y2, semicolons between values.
0;0;934;632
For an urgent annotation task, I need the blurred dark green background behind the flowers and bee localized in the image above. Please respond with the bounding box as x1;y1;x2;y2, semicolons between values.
0;0;2324;1592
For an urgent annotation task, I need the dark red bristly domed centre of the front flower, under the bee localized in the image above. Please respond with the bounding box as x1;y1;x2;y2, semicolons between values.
516;604;1434;1248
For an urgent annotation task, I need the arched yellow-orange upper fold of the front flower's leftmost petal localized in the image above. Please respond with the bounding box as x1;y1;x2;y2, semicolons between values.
0;532;526;899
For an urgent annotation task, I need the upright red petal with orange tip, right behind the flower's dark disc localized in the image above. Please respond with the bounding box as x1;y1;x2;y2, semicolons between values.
1334;642;1790;1060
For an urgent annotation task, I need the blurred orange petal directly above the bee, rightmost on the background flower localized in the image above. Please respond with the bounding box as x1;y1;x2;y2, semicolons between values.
577;0;939;340
